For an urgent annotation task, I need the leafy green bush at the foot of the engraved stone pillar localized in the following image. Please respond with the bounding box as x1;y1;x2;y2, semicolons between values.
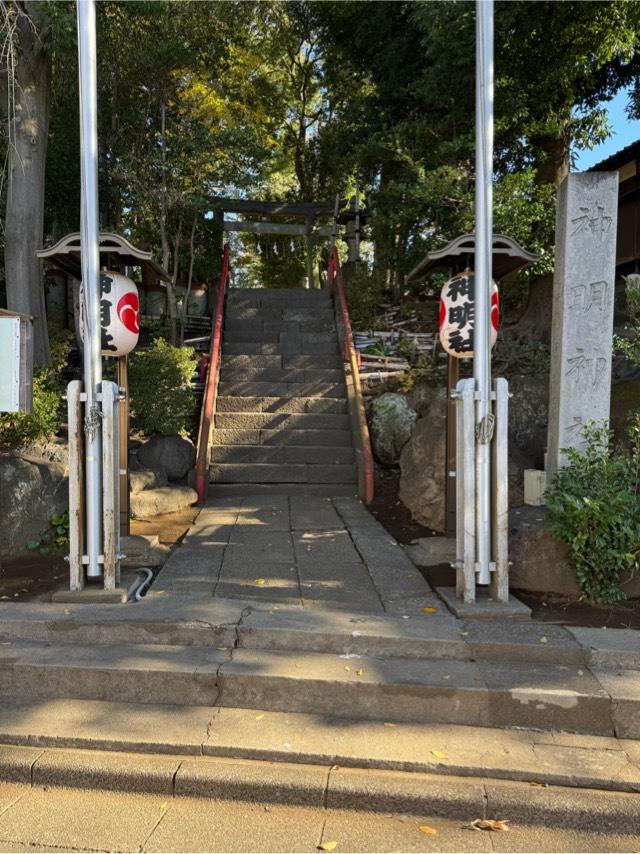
546;424;640;604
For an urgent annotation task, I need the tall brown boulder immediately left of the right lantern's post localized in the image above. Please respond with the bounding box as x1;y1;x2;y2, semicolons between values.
400;399;447;531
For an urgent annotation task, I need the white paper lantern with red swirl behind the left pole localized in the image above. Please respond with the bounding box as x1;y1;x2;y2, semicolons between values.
78;271;140;356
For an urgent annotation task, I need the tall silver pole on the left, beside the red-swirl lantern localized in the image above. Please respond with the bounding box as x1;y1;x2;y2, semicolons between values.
76;0;102;578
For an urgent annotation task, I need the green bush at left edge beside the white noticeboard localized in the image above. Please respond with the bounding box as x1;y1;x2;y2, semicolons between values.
0;329;73;451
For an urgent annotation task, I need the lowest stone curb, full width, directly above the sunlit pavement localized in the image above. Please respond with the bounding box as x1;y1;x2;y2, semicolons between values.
0;745;640;834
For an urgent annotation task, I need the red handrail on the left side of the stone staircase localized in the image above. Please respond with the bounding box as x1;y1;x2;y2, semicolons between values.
196;243;229;503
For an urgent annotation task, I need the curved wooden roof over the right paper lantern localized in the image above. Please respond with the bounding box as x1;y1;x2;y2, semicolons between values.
406;234;539;282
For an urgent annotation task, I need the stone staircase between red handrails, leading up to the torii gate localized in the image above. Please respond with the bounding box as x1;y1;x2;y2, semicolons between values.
210;289;356;494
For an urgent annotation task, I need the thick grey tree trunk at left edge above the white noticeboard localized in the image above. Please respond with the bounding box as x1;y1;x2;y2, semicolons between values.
4;2;51;365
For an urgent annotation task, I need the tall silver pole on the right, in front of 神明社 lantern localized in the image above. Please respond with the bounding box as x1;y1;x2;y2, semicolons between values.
473;0;493;584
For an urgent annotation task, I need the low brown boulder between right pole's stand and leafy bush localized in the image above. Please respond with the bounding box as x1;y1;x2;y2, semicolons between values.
509;507;640;599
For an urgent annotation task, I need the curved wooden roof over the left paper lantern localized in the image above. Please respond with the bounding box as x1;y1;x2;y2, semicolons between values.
36;231;171;282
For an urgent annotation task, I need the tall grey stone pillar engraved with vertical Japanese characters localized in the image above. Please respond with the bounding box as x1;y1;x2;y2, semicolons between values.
547;172;618;483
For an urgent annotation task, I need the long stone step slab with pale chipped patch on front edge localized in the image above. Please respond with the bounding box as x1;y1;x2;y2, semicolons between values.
218;649;620;736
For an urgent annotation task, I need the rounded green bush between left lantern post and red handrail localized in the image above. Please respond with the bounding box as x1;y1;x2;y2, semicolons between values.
129;338;197;436
